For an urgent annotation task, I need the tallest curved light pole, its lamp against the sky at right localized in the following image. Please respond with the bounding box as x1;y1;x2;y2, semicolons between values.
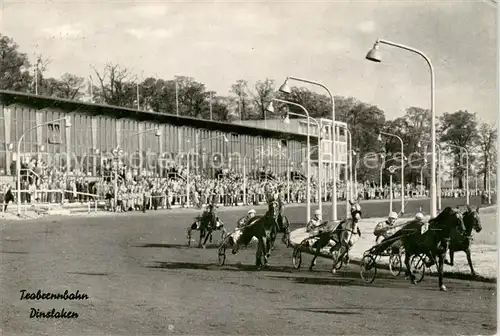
366;39;437;217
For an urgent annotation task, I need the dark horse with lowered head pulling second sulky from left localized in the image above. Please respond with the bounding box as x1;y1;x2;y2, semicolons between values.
232;214;276;268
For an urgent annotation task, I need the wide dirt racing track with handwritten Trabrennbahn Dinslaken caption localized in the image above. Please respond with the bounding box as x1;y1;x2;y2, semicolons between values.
0;197;496;335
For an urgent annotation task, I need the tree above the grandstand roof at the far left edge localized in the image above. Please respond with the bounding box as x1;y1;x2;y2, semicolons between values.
0;34;32;92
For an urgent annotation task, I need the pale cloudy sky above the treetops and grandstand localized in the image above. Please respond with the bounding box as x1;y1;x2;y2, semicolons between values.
0;0;499;123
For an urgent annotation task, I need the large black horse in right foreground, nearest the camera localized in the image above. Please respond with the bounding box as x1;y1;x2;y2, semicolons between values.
400;207;465;291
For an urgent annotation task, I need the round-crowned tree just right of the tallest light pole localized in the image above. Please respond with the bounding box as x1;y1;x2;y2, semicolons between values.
439;111;478;188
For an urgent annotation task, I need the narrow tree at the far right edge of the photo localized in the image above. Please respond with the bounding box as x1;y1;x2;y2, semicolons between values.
477;123;498;189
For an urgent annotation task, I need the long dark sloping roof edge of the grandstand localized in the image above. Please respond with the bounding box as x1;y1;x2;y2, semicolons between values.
0;90;317;143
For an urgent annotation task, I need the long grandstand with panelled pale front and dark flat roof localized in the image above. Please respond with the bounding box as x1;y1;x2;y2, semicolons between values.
0;90;332;177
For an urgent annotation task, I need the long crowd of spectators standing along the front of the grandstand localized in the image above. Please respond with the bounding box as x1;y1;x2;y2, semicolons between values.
0;159;496;212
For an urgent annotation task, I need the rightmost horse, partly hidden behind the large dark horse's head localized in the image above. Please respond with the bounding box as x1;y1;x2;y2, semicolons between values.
444;206;482;276
